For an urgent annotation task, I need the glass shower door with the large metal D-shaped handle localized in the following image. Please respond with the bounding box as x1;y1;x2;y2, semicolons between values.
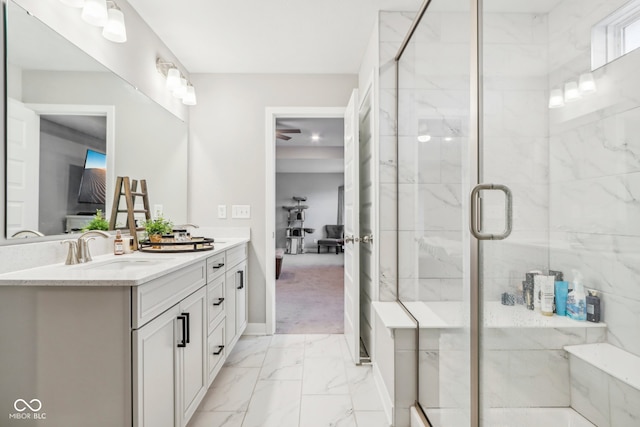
475;0;640;426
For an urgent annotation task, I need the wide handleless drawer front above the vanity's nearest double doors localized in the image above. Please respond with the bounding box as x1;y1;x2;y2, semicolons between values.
131;261;206;329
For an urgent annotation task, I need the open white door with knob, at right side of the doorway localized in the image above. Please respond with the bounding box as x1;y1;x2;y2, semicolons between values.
344;89;360;363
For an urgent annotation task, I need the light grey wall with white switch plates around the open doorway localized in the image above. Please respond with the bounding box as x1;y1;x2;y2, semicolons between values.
188;74;357;323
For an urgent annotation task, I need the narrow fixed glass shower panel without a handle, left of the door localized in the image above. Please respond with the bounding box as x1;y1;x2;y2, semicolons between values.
396;0;471;427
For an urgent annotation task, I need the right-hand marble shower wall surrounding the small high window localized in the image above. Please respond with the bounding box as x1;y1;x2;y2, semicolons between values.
548;0;640;362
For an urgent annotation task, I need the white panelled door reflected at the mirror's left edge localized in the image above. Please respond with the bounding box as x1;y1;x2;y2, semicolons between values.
6;98;40;237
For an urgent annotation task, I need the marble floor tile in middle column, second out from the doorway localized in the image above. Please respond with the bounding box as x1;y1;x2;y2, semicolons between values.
302;358;349;394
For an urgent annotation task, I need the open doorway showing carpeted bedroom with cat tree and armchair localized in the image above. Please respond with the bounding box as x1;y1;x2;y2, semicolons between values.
275;117;344;334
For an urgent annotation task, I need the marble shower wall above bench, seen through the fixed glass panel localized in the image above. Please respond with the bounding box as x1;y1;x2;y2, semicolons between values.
390;9;470;301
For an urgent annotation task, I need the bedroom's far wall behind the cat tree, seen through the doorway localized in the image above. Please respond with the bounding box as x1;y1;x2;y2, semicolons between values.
276;173;344;251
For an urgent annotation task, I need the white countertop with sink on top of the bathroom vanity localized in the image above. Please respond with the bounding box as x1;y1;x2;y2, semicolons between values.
0;237;249;286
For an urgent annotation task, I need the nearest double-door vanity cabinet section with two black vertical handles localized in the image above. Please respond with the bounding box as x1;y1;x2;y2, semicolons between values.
132;262;209;427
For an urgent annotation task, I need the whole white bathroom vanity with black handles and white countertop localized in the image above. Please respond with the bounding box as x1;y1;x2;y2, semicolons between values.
0;238;248;427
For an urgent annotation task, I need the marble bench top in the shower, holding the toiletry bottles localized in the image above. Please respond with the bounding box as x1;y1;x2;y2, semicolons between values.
374;301;607;329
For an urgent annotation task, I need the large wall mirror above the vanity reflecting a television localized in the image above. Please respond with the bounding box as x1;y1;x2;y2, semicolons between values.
5;1;187;242
